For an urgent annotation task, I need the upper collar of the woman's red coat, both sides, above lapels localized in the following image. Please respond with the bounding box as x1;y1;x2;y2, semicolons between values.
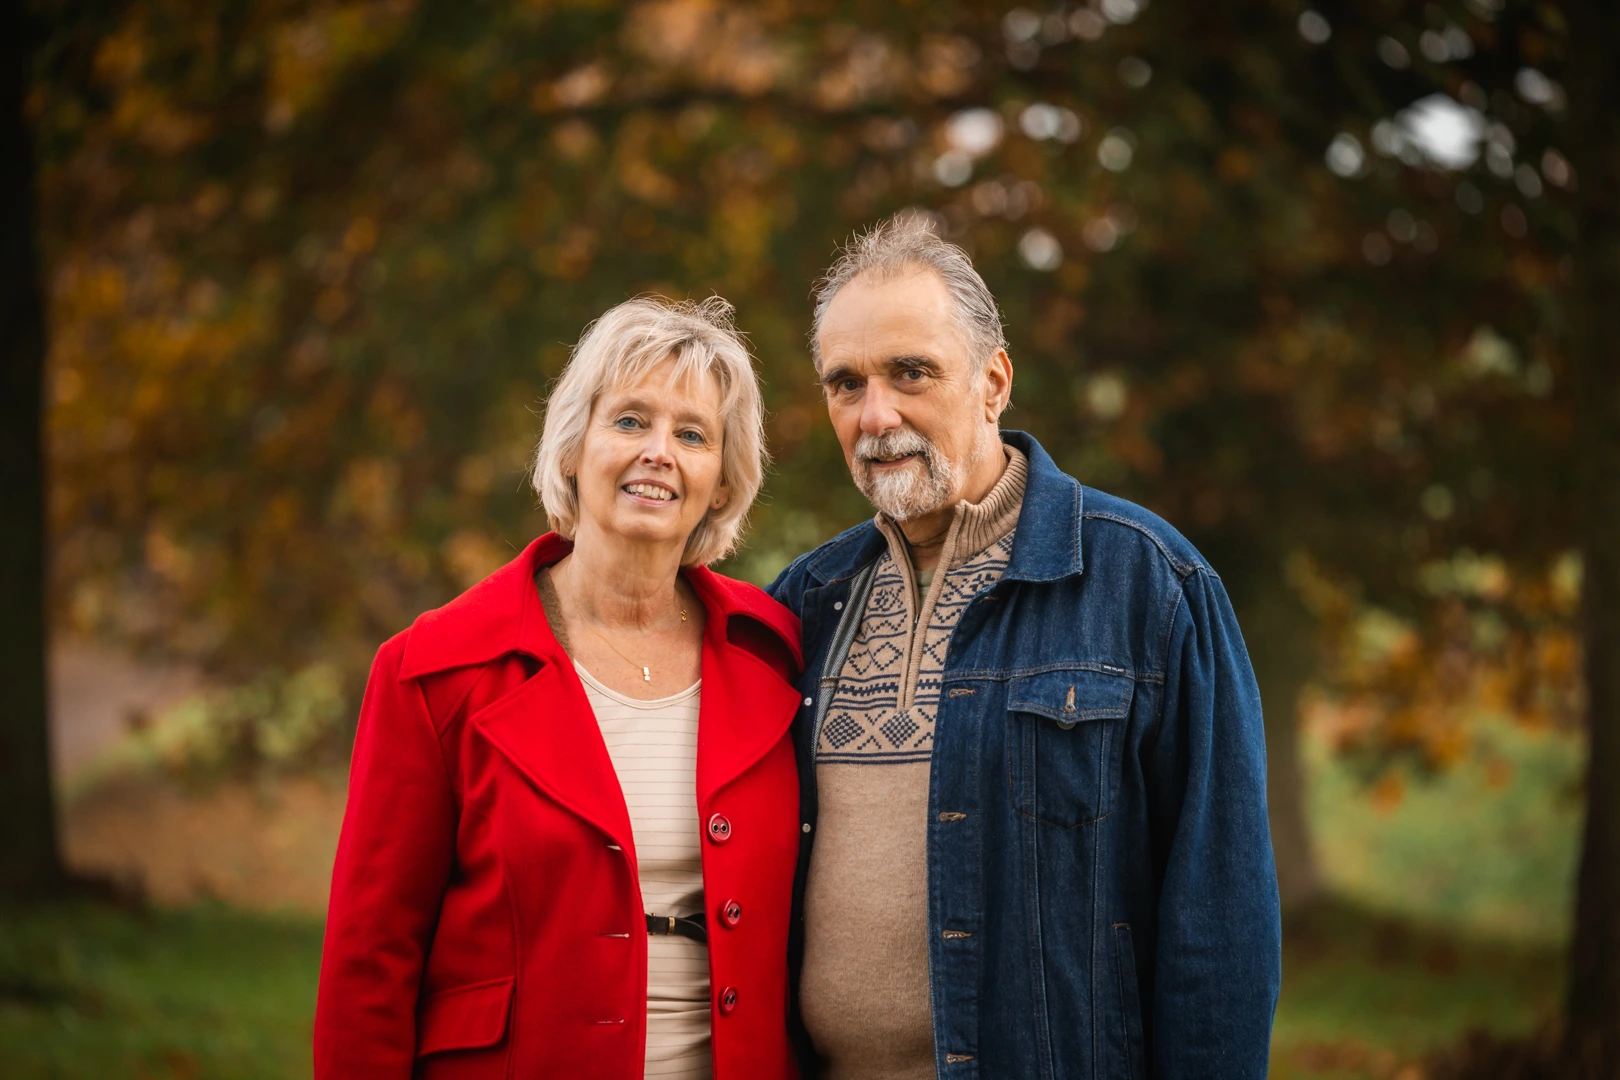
400;533;804;682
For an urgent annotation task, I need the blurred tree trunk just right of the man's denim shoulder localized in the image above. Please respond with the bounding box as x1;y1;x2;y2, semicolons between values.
1239;572;1322;912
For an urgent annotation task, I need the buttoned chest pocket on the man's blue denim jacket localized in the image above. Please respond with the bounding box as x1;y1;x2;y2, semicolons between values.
1008;667;1136;829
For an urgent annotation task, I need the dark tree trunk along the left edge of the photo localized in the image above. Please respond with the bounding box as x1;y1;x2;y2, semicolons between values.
0;0;62;899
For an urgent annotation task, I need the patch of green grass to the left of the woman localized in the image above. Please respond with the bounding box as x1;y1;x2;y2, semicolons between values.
0;904;321;1080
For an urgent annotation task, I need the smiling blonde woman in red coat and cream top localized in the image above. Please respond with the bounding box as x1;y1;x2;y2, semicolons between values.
314;300;800;1080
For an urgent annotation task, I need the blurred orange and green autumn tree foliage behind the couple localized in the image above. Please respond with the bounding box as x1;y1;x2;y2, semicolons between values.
29;0;1607;990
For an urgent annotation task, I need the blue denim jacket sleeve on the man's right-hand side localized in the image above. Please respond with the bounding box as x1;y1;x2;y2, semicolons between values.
1149;568;1281;1080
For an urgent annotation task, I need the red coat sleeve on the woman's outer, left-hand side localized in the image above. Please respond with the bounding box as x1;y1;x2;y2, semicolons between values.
314;635;457;1080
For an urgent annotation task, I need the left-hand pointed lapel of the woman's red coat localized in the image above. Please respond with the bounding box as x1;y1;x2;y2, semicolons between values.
471;662;635;855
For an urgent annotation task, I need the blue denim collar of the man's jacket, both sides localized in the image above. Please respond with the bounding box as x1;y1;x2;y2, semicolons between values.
810;431;1085;585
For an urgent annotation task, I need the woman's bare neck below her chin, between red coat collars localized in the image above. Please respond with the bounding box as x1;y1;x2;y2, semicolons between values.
551;523;687;630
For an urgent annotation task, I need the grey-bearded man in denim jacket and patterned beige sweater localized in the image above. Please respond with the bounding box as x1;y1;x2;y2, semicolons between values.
771;217;1281;1080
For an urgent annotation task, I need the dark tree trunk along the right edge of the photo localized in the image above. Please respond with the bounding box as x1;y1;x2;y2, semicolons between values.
1565;0;1620;1080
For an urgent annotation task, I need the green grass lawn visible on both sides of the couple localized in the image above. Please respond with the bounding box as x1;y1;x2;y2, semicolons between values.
0;712;1580;1080
